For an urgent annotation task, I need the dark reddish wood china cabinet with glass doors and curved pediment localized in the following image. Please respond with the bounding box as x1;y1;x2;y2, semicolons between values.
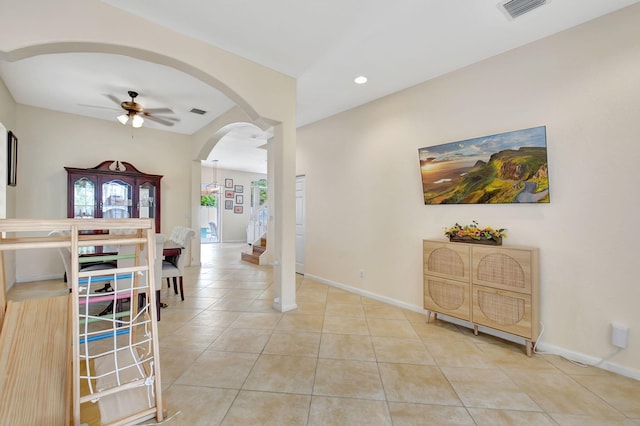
65;161;162;232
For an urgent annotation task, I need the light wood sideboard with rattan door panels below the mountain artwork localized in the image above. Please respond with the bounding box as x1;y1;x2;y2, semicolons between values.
423;240;540;356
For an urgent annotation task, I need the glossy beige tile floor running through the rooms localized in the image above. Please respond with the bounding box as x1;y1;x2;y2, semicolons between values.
9;244;640;426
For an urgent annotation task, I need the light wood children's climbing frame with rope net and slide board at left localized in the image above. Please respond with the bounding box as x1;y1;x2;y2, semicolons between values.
0;219;164;425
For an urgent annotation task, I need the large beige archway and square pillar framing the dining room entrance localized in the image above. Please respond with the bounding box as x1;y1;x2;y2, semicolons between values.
0;0;296;311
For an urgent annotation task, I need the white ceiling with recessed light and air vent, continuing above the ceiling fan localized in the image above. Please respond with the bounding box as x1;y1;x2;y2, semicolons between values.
0;0;640;173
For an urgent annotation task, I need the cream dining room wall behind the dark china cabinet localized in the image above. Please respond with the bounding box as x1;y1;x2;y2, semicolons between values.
15;105;191;282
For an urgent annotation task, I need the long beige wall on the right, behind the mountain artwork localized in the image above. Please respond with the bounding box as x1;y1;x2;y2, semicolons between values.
296;5;640;378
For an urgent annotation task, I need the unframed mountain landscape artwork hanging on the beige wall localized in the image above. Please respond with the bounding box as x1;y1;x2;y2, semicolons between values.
418;126;549;205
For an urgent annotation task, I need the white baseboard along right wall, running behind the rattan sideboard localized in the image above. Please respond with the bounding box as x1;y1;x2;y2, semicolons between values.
305;274;640;380
